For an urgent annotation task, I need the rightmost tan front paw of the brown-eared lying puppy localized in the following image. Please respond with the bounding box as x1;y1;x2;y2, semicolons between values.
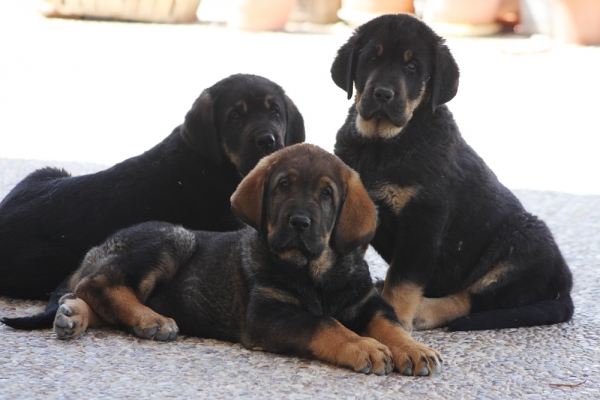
390;341;443;376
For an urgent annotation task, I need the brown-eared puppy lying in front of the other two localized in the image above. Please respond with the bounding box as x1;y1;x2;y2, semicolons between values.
7;144;442;375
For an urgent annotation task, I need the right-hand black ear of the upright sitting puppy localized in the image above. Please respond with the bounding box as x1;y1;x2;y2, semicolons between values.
431;38;460;112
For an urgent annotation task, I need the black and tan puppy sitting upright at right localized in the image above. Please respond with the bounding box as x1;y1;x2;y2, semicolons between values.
331;14;573;330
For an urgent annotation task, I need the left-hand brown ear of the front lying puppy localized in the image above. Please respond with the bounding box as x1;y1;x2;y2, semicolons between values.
231;156;275;235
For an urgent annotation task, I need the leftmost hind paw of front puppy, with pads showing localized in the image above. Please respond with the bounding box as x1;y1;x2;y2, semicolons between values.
54;293;106;339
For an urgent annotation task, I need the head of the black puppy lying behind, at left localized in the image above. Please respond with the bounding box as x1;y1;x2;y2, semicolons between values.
181;74;304;176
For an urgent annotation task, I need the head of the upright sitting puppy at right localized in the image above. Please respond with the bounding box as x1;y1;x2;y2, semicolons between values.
331;14;459;138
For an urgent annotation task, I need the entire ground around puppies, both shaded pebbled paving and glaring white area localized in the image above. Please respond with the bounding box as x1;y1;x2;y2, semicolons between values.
0;0;600;399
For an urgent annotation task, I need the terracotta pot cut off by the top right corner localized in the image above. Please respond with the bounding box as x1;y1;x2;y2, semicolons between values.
552;0;600;44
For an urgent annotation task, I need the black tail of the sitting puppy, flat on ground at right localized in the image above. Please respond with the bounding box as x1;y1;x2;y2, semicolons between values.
446;294;575;332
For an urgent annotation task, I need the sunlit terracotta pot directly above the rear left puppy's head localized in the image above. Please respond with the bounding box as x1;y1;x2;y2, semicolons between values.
227;0;297;31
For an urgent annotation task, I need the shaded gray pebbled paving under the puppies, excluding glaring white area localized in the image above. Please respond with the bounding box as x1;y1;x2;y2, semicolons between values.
0;159;600;399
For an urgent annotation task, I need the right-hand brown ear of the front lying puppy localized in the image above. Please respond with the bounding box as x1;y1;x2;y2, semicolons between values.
331;171;377;255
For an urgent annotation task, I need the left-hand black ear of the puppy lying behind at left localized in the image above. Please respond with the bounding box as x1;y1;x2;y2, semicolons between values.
181;89;223;166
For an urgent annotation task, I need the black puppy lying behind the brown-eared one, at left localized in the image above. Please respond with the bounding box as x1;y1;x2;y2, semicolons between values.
0;75;304;306
